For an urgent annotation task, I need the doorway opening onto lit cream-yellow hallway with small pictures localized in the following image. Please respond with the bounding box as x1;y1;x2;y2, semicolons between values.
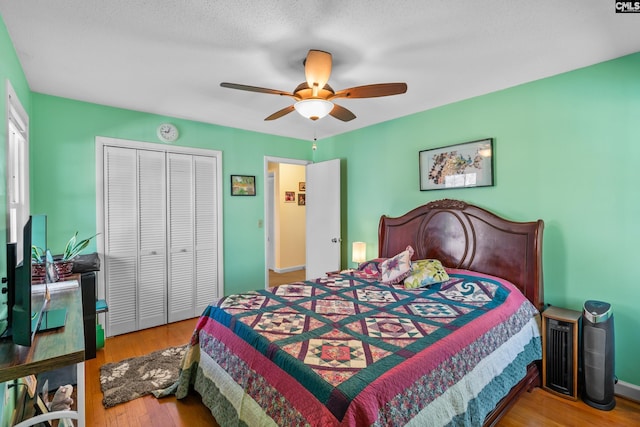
264;157;311;289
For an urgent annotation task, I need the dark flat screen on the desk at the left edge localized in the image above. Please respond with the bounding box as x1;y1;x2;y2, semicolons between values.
3;216;47;346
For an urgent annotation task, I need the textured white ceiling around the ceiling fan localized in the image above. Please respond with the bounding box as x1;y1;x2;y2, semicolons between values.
0;0;640;140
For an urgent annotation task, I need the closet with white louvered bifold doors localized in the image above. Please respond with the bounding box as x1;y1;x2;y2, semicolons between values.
96;138;222;335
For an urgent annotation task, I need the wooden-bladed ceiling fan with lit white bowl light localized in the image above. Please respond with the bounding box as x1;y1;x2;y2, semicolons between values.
220;49;407;122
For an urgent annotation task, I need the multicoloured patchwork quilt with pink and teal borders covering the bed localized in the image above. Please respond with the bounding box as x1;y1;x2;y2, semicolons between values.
176;269;541;426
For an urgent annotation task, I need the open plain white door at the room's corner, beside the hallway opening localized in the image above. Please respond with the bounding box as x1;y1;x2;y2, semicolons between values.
305;159;342;280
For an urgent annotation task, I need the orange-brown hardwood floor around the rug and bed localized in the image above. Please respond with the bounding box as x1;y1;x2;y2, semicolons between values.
85;319;640;427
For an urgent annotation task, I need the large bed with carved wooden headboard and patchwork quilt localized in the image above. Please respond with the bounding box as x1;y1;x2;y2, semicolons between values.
173;200;543;426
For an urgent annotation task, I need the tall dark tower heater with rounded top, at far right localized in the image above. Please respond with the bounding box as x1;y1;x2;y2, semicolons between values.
582;301;616;411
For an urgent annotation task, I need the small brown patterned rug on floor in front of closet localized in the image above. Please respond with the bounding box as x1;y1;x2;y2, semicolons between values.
100;346;186;408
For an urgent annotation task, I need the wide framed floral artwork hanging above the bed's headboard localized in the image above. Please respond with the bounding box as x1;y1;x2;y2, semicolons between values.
418;138;493;191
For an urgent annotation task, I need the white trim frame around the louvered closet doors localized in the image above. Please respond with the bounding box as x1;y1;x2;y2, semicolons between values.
95;136;224;336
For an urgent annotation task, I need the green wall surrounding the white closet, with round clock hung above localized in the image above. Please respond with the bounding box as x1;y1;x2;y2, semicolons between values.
31;93;312;294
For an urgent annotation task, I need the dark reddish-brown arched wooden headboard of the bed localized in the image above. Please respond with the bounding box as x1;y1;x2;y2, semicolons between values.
378;199;544;310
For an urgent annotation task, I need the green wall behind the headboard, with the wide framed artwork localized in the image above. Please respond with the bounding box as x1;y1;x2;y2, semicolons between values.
318;53;640;385
